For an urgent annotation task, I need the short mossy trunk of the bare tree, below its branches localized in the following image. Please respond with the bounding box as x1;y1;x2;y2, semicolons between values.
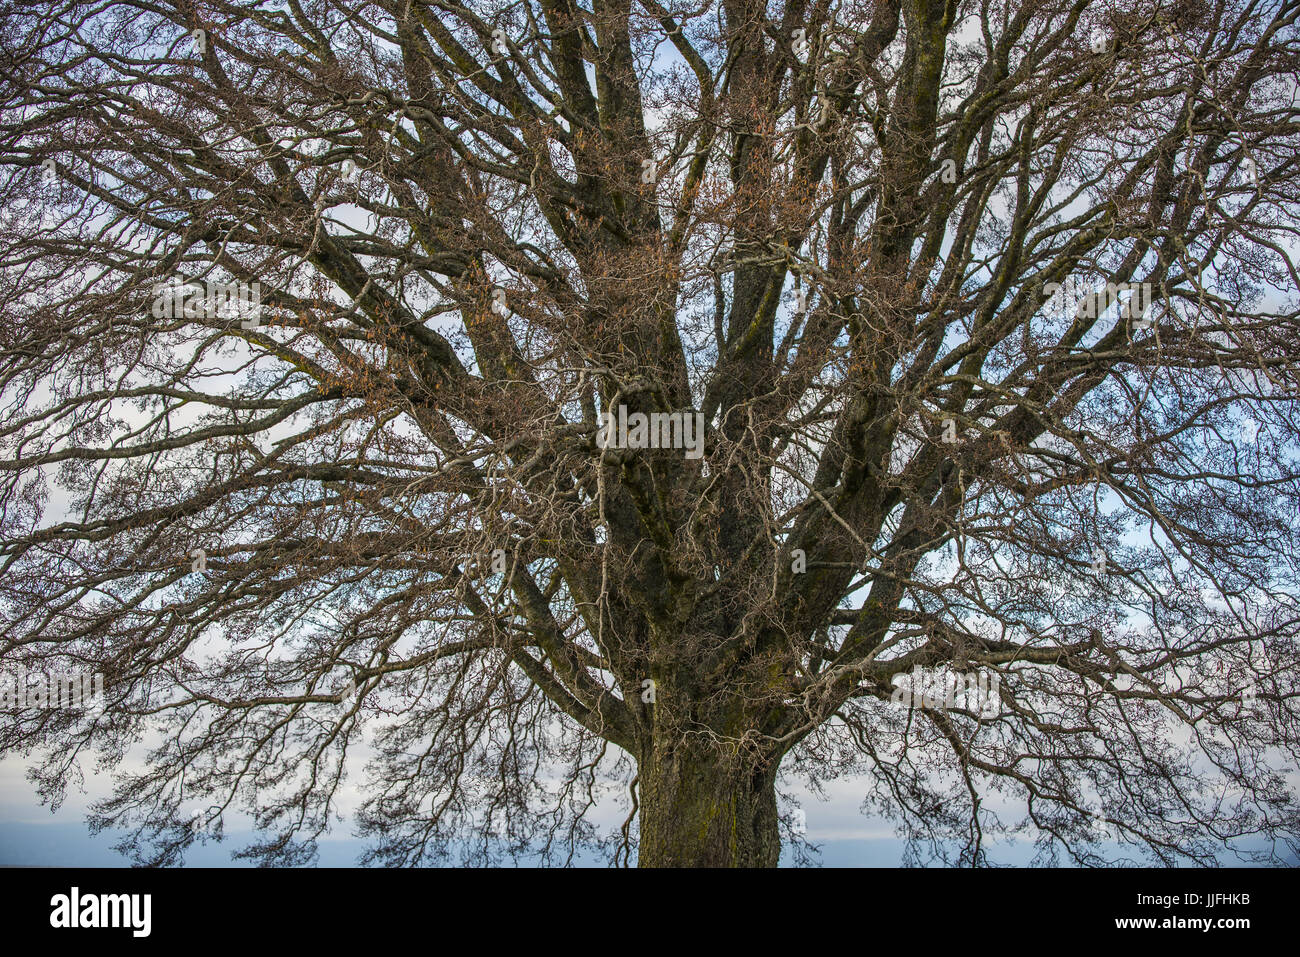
637;741;781;867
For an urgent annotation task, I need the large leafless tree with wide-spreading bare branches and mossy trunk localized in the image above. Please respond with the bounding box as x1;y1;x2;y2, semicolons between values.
0;0;1300;866
